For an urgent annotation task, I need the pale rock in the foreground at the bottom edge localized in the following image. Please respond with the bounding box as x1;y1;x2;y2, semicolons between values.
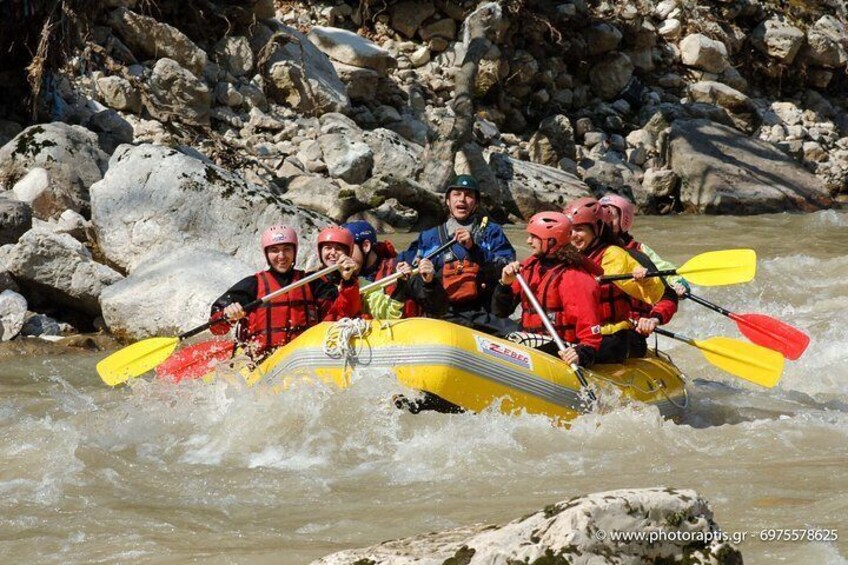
313;488;742;565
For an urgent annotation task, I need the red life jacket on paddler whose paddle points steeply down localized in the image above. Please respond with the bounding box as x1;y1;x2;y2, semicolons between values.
521;256;578;343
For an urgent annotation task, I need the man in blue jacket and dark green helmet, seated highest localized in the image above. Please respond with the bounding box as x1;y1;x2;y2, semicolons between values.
397;175;518;336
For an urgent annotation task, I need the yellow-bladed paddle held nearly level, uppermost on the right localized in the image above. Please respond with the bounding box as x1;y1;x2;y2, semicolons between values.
600;249;757;286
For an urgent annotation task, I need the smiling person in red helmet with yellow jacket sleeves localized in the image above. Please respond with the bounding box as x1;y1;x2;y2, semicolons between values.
564;197;665;363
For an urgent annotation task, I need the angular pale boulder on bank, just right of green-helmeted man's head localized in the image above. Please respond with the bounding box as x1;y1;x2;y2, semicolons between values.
489;153;589;220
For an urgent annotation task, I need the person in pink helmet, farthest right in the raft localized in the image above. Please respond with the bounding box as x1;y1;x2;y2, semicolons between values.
598;194;685;357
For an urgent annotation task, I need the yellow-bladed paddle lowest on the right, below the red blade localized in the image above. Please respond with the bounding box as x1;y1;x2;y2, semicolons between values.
654;328;783;388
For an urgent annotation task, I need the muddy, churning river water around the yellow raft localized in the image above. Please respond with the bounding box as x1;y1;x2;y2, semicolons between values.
0;211;848;564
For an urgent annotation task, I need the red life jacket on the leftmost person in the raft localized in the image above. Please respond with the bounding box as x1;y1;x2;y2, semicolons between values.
245;269;320;351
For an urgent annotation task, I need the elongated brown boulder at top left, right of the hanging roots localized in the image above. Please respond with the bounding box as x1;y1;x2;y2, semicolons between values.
109;8;206;77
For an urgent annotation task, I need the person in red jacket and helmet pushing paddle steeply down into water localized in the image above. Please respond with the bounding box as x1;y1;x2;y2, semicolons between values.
492;212;601;367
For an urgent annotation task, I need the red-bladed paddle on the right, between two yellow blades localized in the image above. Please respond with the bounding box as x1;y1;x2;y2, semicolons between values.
686;292;810;361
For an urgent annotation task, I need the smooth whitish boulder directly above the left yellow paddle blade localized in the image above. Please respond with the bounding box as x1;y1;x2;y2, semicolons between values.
100;247;252;340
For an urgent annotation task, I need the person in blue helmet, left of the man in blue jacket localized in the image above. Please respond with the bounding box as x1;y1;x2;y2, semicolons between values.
342;220;448;320
